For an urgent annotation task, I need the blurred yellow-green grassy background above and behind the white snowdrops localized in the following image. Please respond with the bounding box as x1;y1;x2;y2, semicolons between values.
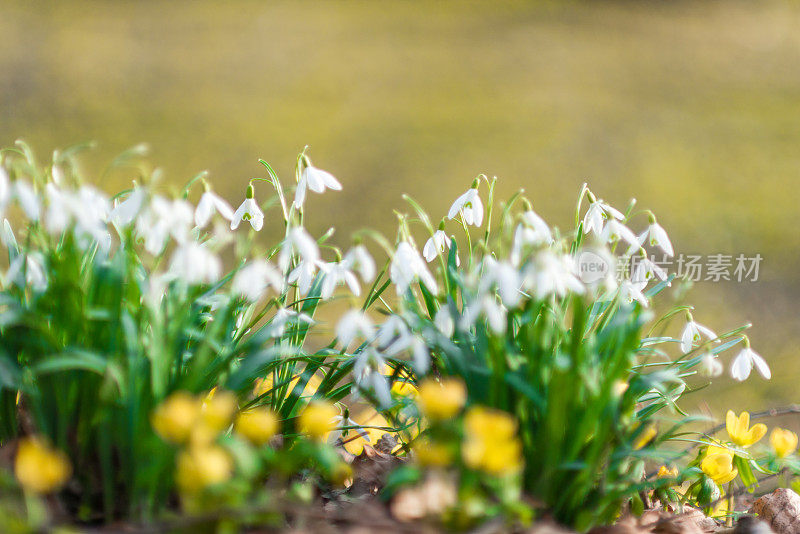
0;0;800;415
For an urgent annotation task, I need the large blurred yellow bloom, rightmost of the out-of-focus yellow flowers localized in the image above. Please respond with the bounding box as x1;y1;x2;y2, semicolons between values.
461;406;522;476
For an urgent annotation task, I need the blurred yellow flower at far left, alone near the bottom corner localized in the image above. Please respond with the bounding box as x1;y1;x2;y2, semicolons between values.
14;437;72;493
